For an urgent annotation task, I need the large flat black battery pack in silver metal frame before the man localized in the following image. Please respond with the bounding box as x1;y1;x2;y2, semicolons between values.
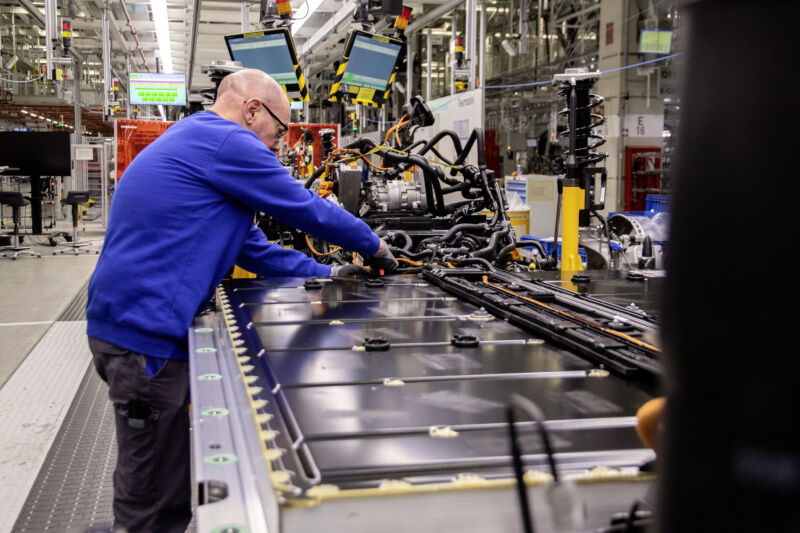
189;267;660;533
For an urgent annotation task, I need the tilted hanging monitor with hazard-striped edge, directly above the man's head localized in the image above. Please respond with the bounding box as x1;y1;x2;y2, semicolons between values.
225;28;309;102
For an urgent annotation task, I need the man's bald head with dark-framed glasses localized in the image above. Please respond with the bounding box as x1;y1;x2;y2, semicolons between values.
211;69;291;151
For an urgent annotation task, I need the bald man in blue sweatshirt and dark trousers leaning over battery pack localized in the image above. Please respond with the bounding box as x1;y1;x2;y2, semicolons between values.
86;70;397;533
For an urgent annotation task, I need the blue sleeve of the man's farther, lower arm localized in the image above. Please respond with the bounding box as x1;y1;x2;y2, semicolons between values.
236;224;331;277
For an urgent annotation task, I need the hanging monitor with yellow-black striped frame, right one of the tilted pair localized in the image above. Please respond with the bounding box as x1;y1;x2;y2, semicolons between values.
330;30;405;107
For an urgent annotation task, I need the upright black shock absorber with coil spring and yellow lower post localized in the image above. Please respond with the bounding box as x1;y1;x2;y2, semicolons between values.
553;68;608;271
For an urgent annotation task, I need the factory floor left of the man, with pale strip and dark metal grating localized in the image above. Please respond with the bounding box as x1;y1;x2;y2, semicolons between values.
0;224;114;533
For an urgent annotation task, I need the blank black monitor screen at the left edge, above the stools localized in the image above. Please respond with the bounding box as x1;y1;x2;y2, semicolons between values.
0;131;72;176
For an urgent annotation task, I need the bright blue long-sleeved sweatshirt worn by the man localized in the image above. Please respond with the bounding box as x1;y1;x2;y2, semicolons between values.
86;111;380;359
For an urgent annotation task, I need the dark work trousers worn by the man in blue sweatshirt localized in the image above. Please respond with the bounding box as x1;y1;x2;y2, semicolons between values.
89;337;192;533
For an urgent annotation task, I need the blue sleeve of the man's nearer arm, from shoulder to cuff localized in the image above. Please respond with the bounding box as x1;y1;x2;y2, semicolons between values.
207;129;380;256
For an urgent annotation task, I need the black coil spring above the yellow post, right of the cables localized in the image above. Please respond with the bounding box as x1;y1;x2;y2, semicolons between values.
558;83;608;166
